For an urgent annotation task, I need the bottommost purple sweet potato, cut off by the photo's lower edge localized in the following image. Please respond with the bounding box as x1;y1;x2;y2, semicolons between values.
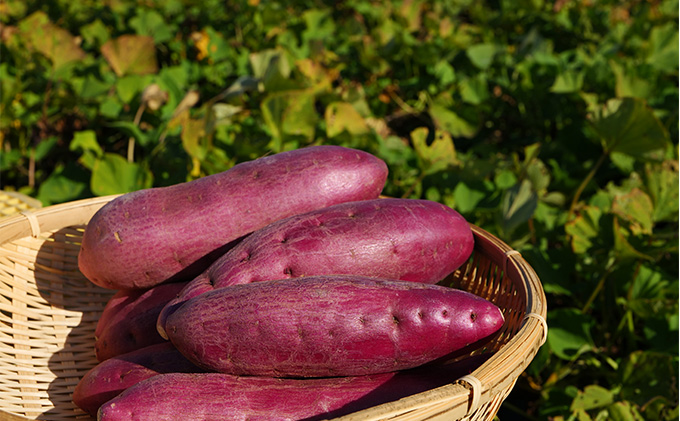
98;355;488;421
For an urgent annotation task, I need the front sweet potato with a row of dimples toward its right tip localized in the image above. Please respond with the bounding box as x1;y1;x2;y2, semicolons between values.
166;276;504;377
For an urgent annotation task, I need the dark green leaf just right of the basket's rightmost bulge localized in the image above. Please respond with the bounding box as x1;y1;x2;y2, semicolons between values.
547;308;593;360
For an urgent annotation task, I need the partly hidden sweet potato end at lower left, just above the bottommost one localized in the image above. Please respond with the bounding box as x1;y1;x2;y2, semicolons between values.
73;342;203;415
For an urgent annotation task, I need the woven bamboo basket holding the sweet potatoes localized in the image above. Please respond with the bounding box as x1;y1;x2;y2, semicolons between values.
0;196;547;421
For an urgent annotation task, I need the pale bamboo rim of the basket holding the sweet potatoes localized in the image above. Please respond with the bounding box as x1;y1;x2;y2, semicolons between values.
0;195;547;421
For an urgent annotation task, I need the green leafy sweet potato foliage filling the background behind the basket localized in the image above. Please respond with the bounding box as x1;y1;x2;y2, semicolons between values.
0;0;679;420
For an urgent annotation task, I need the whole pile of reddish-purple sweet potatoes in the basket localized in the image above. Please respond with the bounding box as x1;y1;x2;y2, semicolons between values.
73;146;504;420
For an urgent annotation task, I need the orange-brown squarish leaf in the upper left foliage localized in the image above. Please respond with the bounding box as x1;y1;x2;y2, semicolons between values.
101;34;158;77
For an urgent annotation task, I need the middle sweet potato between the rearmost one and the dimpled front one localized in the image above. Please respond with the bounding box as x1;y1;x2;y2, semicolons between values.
157;199;474;337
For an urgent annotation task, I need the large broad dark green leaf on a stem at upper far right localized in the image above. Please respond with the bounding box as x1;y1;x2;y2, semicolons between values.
590;98;669;158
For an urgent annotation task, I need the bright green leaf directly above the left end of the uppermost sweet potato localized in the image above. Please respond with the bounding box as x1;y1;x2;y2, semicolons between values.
90;153;153;196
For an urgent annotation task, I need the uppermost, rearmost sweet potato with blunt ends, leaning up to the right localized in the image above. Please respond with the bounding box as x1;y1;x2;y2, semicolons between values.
78;145;388;289
